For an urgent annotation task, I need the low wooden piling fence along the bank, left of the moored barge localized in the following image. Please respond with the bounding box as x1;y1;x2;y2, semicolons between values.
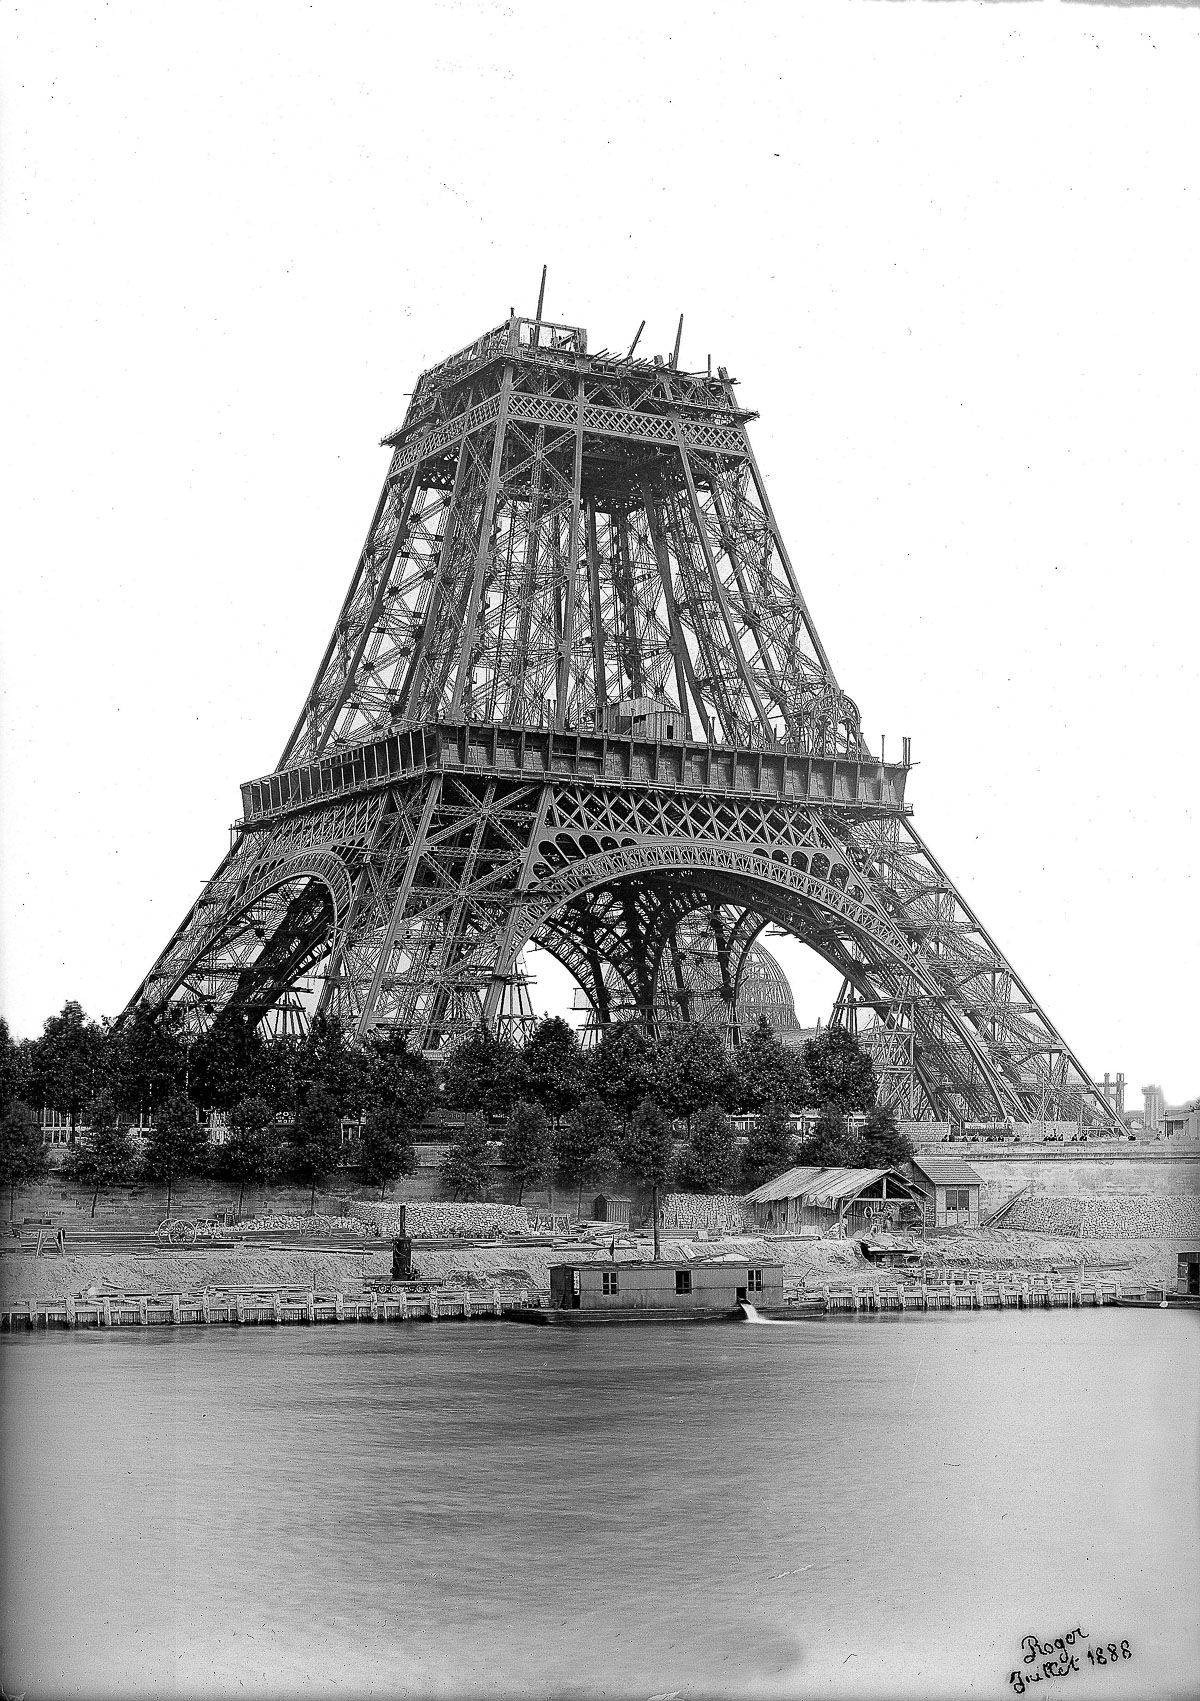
0;1288;538;1330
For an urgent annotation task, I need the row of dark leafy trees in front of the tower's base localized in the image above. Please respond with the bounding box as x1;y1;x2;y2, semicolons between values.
0;1004;907;1216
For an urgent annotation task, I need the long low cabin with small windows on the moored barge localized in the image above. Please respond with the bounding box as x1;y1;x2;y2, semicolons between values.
550;1257;783;1317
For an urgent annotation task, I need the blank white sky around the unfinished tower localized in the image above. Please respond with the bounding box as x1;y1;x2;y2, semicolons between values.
0;0;1200;1102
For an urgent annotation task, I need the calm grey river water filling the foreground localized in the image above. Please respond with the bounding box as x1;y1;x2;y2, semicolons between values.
0;1308;1200;1701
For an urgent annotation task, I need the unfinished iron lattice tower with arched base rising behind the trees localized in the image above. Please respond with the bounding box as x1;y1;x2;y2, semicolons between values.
129;316;1115;1128
